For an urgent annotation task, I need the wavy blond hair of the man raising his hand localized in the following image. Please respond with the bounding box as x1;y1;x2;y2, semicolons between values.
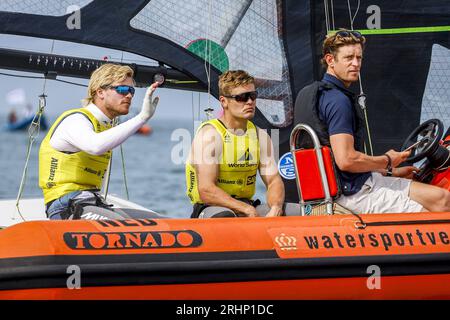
83;63;134;106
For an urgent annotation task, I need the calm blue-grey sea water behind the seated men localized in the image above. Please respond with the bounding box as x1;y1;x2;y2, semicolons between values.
0;115;265;217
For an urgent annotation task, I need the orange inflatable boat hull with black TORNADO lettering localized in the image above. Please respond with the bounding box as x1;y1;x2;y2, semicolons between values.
0;213;450;300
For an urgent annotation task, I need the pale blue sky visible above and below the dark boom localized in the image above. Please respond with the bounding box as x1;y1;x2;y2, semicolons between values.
0;34;220;119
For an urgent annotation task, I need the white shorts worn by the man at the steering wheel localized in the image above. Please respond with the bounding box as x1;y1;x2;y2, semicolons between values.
336;172;423;213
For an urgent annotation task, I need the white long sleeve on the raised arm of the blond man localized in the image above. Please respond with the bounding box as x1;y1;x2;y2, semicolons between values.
50;113;145;155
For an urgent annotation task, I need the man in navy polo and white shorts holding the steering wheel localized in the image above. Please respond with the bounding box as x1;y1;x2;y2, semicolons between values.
302;30;450;213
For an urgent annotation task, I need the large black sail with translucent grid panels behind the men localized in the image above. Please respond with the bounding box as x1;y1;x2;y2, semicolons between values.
0;0;450;202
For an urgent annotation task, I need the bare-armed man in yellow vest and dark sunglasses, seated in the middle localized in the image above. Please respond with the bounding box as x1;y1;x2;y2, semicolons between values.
186;70;298;218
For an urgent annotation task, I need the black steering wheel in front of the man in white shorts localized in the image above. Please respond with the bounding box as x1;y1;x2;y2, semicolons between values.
401;119;444;163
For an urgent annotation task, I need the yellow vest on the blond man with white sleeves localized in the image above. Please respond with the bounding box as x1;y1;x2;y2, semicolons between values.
39;108;111;203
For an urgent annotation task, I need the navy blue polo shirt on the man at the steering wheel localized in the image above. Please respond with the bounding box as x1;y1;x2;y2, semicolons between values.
319;73;371;196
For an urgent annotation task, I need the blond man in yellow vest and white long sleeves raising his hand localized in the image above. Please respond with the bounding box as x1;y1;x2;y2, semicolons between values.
39;63;159;219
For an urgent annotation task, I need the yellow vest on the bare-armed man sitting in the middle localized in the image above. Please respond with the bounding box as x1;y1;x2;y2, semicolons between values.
186;119;260;204
